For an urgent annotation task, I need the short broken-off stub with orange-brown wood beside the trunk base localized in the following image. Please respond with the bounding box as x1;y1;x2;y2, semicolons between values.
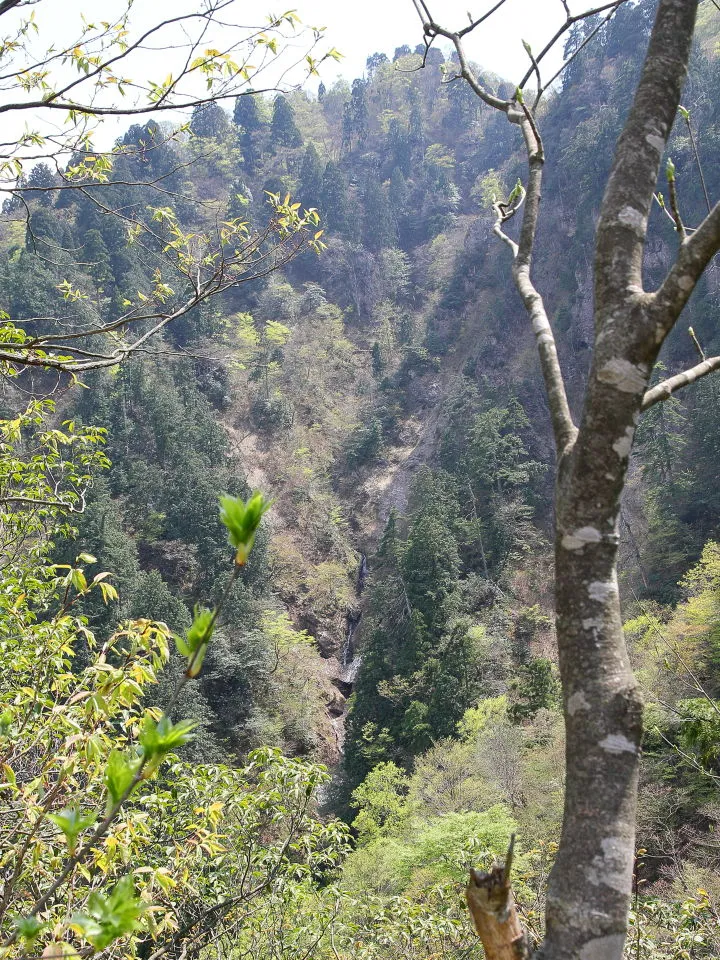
465;837;530;960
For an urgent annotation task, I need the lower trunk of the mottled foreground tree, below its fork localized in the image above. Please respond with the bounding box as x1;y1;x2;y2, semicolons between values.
540;432;642;960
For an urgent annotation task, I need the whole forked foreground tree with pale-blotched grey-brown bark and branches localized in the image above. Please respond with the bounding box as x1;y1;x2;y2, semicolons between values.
415;0;720;960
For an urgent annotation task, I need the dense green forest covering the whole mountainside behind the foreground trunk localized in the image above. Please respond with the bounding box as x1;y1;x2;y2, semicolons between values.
0;0;720;960
